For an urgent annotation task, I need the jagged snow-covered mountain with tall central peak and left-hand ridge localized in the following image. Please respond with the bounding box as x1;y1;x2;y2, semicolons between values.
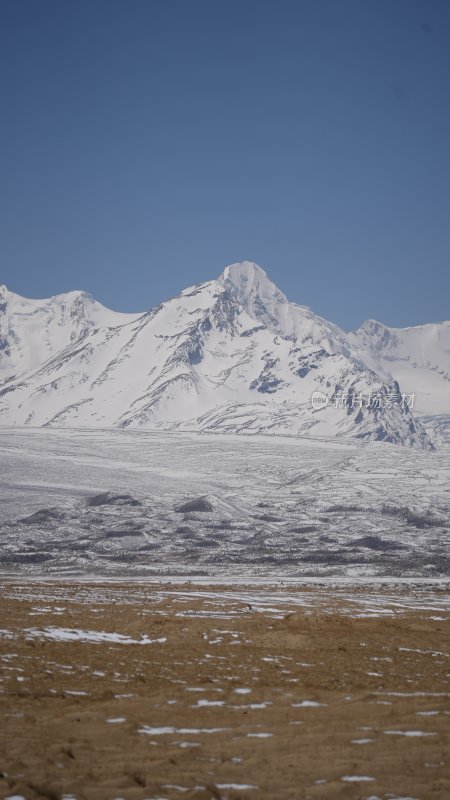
0;262;442;447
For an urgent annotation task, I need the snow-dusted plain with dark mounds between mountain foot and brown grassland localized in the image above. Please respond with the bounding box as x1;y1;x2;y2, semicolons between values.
0;428;450;579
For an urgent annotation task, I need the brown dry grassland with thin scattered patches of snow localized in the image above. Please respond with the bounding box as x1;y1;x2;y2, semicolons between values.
0;580;450;800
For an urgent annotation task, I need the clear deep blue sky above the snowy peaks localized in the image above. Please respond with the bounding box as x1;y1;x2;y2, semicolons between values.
0;0;450;328
